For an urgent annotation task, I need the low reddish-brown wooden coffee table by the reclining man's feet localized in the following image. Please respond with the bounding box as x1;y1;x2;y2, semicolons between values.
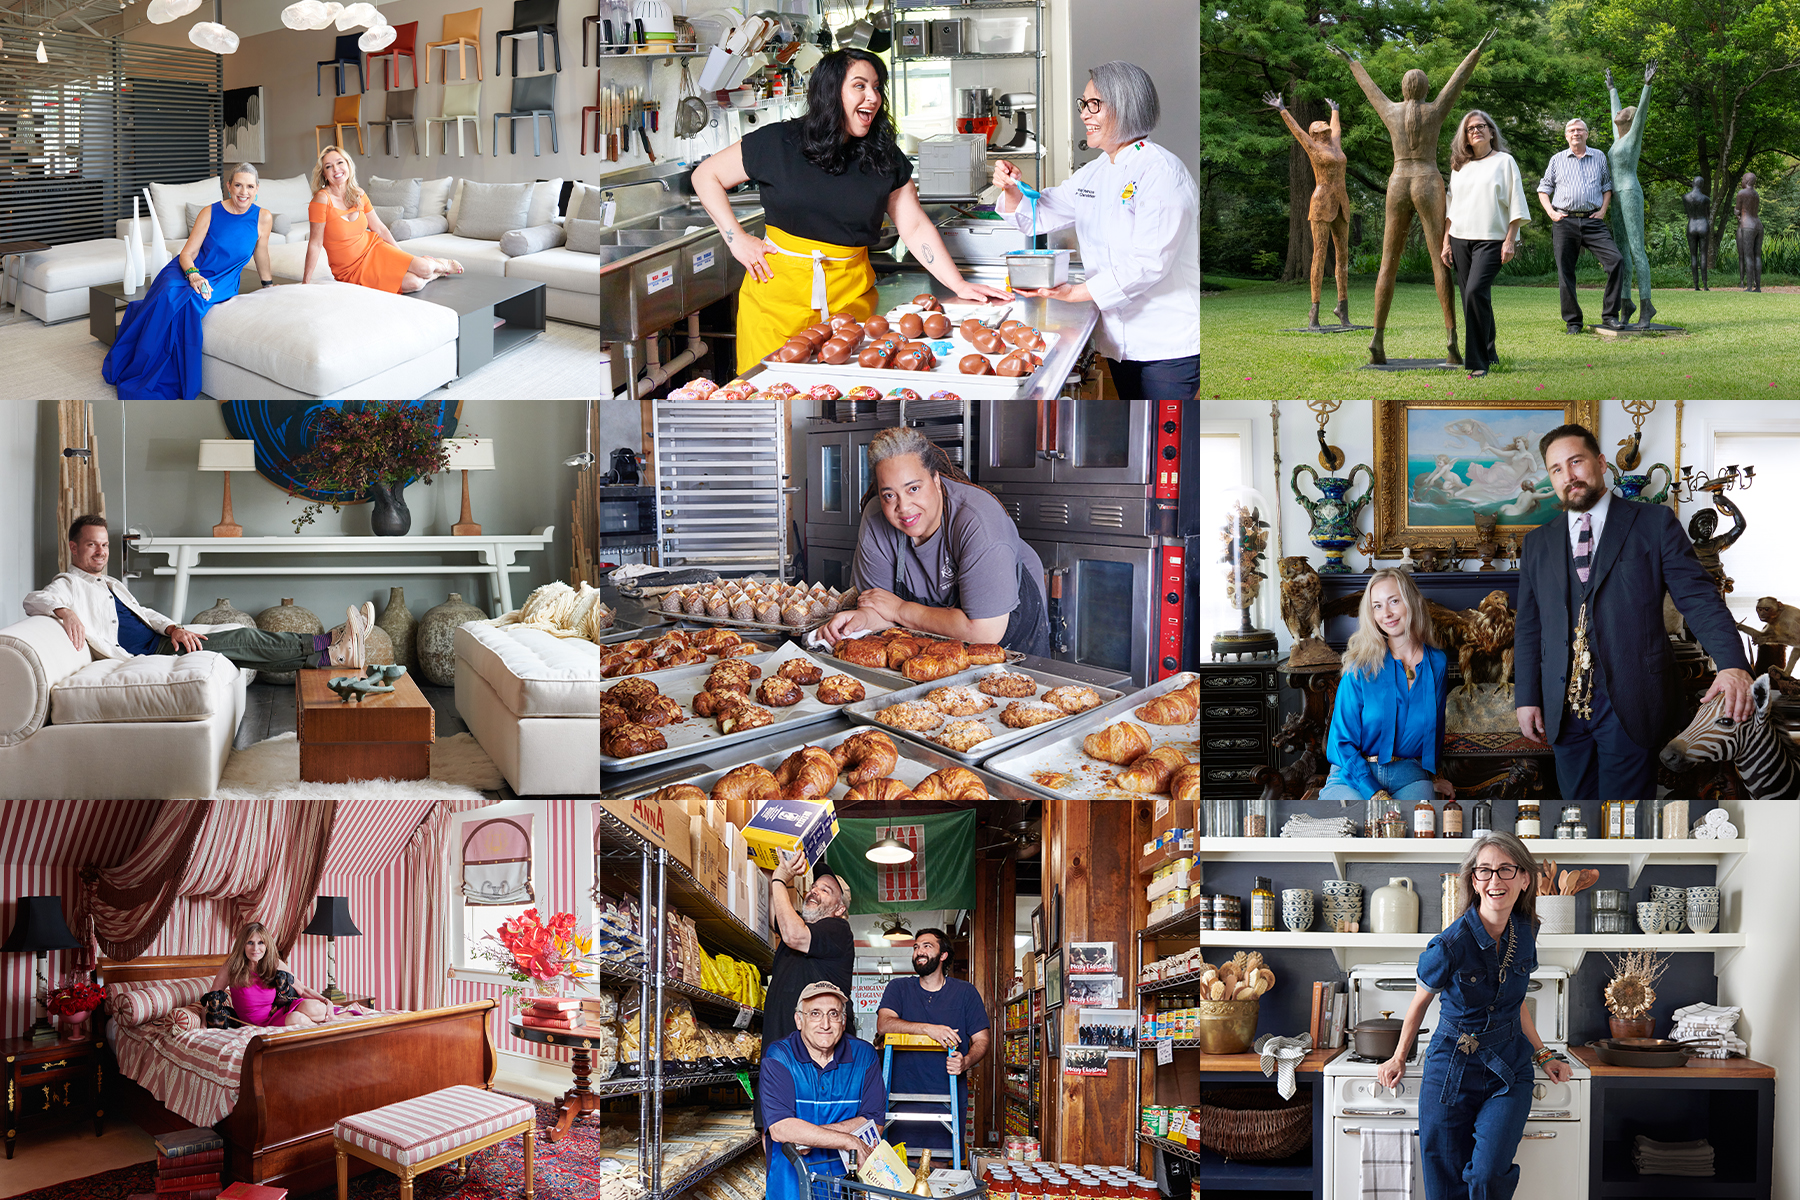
293;667;437;783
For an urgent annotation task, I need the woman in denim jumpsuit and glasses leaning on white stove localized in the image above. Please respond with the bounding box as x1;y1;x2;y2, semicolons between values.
1377;833;1570;1200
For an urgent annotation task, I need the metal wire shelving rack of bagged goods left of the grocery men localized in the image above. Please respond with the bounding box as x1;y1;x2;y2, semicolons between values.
592;805;774;1200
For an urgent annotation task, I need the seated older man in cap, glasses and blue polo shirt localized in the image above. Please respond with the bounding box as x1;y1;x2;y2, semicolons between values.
760;981;887;1200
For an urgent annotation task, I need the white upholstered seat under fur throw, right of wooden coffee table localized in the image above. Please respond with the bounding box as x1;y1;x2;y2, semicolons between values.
455;621;599;795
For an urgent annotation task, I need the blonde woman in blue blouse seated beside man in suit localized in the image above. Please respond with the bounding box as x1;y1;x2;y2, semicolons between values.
1319;570;1456;824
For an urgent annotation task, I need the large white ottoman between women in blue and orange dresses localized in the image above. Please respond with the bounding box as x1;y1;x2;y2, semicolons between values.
200;281;457;399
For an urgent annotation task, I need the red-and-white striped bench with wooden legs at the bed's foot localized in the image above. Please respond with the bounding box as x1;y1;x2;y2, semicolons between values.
331;1085;538;1200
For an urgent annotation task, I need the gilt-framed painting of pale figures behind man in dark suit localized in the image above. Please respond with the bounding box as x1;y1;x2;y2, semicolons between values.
1373;399;1600;558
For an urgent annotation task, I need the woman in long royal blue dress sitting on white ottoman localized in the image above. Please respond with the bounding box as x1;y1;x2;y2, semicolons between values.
101;162;274;399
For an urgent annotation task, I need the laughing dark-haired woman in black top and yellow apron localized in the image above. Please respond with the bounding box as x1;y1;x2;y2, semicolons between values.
693;50;1012;372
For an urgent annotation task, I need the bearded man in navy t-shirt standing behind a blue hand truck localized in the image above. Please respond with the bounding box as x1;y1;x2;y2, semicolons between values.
875;928;988;1150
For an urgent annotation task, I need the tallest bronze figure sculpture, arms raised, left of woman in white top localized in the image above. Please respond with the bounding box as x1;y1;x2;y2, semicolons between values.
1330;31;1494;365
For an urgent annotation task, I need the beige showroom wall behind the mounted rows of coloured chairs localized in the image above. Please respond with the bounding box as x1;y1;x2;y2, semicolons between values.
126;0;599;184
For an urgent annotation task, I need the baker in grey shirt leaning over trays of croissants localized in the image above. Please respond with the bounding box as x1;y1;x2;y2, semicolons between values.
819;426;1049;657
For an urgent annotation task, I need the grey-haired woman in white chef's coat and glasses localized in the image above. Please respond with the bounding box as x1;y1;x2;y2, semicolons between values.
994;63;1201;399
